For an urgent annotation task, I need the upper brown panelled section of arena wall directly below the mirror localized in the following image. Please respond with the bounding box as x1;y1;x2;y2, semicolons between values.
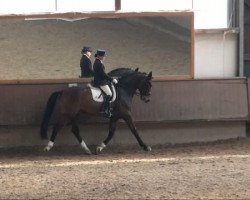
0;79;248;125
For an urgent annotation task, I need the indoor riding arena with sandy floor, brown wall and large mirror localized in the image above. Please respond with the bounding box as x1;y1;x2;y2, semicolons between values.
0;0;250;199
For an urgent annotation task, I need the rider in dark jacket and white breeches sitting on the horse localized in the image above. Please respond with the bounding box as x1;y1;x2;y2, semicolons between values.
93;49;118;117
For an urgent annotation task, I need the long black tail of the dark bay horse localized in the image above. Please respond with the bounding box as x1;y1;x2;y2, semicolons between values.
40;91;62;139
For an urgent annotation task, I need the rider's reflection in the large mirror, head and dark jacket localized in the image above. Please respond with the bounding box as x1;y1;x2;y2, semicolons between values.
80;47;93;77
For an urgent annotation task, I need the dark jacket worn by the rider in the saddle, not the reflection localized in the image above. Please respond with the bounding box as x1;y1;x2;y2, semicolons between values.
93;59;112;86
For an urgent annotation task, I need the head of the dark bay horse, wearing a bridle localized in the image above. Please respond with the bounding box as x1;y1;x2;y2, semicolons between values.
138;72;152;103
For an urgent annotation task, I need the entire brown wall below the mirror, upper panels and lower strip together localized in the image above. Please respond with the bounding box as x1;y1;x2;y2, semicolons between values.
0;79;249;147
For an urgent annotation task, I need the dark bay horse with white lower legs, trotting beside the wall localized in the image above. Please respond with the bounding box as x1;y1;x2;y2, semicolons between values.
40;69;152;154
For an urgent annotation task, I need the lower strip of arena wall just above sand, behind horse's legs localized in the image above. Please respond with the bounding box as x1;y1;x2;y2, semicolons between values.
0;121;246;148
